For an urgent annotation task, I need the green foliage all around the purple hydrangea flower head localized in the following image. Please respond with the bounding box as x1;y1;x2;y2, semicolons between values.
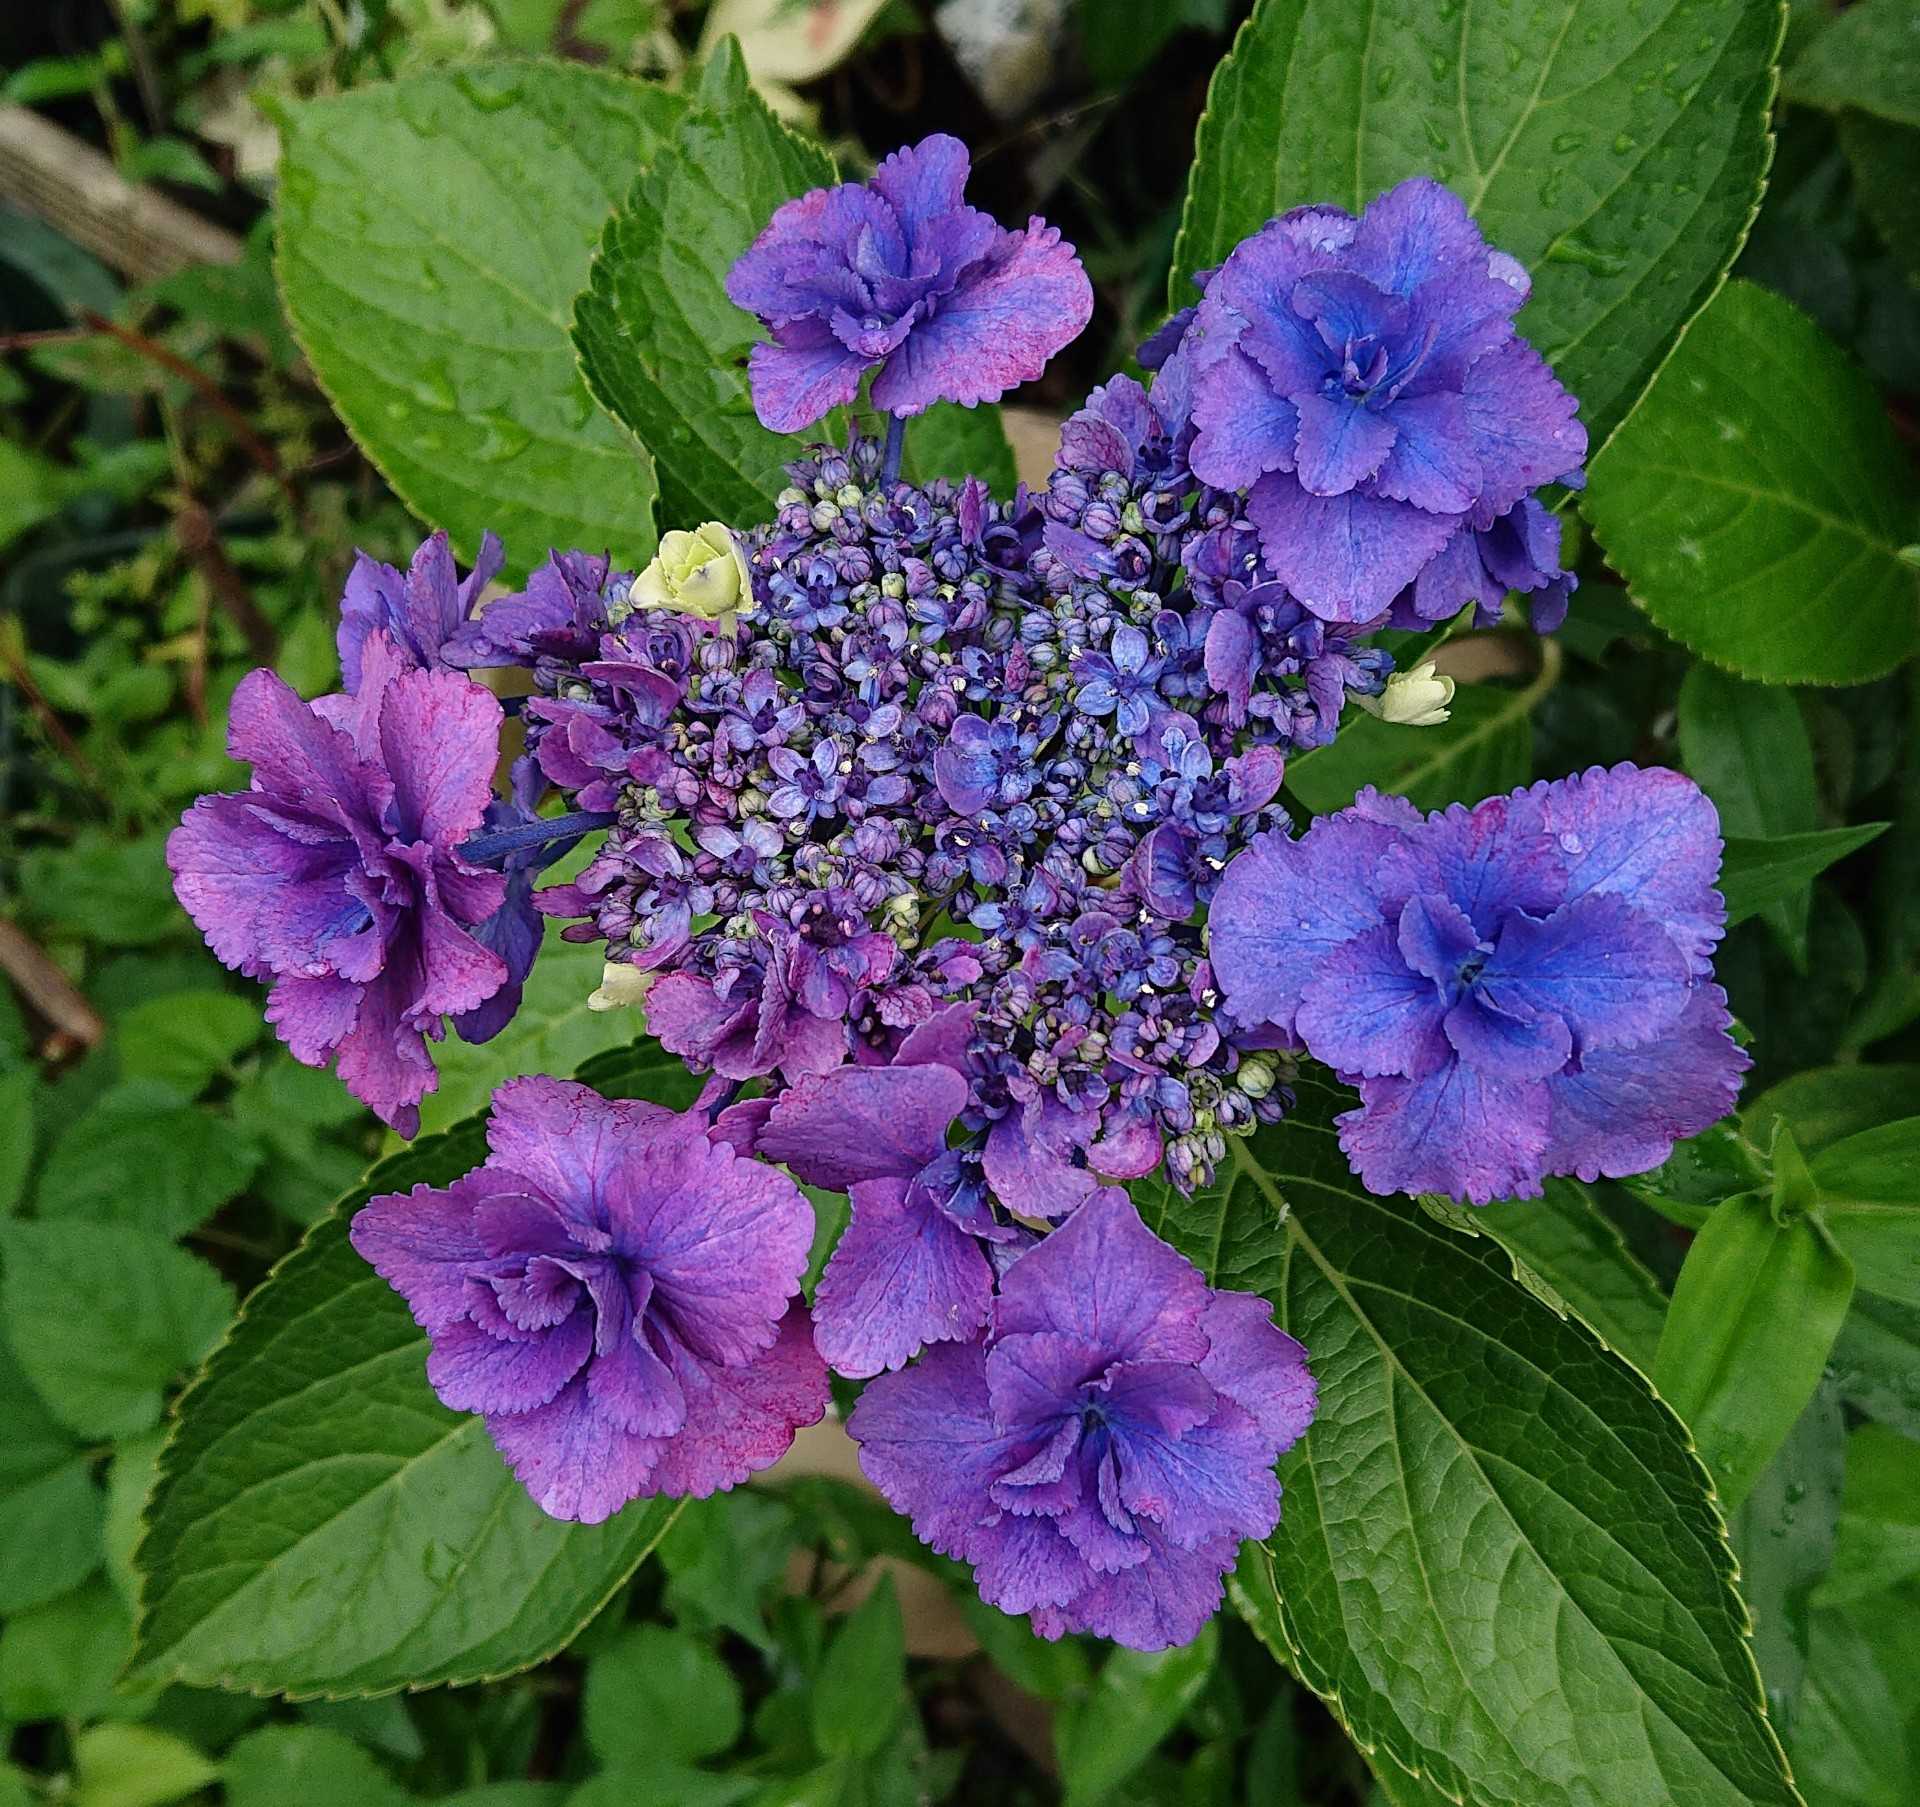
0;0;1920;1807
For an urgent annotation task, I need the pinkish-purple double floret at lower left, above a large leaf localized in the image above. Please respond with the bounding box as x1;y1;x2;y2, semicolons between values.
351;1079;828;1525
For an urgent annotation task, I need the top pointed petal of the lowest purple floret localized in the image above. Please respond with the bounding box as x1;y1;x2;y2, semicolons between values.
993;1187;1208;1361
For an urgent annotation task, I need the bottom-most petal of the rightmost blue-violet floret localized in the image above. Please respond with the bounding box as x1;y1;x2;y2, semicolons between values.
1336;1060;1548;1204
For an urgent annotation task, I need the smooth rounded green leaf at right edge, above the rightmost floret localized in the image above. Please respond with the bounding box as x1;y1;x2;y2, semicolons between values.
1582;282;1920;684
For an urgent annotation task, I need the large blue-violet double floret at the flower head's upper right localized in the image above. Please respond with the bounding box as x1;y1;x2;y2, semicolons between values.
1183;179;1586;622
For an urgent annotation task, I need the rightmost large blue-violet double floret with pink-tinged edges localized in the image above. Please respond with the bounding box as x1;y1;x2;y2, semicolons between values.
1212;764;1749;1204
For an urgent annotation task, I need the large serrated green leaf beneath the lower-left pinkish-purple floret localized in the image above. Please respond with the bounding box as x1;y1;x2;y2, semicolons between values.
136;1050;706;1696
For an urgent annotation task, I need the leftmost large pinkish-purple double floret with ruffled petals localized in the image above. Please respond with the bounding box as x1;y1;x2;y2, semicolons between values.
167;630;513;1135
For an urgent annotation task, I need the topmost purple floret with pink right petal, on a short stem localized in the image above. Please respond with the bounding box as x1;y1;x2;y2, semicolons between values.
726;133;1092;432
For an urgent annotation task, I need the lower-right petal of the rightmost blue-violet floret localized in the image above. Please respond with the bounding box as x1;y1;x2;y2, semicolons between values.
1546;985;1753;1181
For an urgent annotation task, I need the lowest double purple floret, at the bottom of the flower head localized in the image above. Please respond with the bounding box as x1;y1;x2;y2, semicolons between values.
847;1191;1315;1650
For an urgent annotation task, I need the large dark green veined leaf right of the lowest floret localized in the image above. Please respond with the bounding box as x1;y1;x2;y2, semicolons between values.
1146;1079;1797;1807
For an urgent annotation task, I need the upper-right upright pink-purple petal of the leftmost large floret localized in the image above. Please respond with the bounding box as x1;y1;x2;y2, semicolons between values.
380;672;505;848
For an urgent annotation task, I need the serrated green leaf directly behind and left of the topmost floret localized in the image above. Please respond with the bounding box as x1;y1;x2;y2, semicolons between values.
574;42;833;528
